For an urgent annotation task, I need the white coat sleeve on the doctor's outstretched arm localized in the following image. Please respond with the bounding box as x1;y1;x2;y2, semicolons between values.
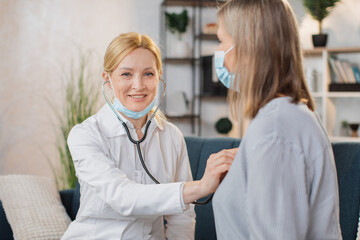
68;125;183;216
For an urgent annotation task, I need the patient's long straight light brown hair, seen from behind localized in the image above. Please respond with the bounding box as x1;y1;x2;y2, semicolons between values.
218;0;315;119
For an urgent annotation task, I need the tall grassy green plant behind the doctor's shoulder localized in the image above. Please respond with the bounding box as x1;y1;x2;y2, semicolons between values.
48;54;99;189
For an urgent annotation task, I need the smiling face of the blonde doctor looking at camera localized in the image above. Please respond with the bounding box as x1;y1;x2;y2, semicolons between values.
105;48;160;112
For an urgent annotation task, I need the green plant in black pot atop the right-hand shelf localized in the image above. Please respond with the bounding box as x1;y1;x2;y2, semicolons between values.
303;0;340;47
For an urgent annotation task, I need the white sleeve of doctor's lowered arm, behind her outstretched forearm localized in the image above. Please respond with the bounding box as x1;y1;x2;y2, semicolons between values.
165;131;195;240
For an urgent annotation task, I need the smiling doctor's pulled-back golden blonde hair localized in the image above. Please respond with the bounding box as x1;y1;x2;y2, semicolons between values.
104;32;166;120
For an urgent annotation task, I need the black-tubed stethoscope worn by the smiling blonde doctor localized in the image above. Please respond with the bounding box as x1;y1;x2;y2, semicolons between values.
101;74;213;205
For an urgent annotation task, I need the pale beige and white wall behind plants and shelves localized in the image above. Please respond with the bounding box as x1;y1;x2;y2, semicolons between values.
0;0;360;176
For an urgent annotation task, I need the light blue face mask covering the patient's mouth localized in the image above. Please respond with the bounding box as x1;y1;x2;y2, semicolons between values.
214;47;235;88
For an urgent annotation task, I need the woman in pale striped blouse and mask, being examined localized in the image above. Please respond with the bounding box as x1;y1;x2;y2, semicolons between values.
213;0;341;240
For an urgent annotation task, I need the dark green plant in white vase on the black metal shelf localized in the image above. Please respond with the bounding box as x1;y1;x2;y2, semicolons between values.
165;9;190;58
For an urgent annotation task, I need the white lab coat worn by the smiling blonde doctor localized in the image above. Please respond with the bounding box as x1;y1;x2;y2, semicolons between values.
62;105;195;240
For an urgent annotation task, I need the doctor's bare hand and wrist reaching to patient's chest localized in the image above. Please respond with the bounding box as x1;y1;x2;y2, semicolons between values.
183;148;238;204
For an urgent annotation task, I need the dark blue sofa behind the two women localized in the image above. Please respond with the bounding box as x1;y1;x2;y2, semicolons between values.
0;137;360;240
